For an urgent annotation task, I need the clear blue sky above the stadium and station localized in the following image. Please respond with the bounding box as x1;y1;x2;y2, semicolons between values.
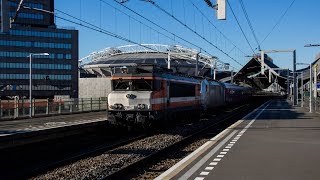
55;0;320;70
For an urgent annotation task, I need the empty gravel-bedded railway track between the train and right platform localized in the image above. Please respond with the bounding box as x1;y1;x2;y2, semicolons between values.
33;100;262;179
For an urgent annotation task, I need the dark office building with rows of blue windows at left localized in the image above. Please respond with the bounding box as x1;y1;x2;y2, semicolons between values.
0;0;78;99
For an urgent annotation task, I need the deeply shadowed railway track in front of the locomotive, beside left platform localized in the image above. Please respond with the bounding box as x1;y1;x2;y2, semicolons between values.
0;127;147;179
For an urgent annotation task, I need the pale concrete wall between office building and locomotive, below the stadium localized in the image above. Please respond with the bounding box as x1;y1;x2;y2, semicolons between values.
79;78;111;98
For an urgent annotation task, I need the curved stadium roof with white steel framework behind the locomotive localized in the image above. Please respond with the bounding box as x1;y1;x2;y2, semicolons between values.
79;44;232;77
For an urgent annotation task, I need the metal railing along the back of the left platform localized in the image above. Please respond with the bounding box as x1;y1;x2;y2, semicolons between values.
0;97;108;119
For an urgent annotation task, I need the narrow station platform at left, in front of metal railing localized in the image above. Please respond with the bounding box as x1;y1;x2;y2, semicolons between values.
0;111;107;149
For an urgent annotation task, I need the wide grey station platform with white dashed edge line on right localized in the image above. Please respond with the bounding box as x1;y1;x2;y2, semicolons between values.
156;100;320;180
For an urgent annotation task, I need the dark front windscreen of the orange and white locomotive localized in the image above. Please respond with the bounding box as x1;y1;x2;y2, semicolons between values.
112;79;153;91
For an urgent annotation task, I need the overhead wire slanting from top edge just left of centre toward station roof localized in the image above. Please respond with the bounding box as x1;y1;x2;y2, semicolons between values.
145;0;243;66
